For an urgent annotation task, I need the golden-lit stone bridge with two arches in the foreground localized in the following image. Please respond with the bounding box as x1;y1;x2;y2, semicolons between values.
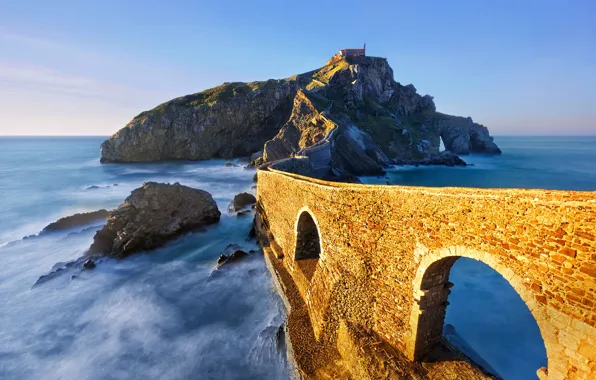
257;168;596;380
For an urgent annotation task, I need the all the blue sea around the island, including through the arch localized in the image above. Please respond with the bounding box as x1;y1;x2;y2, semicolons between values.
0;137;596;380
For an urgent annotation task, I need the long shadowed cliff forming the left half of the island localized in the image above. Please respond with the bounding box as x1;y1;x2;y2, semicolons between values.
101;76;310;162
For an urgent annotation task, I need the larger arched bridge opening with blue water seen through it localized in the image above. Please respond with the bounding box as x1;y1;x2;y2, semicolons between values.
409;251;547;379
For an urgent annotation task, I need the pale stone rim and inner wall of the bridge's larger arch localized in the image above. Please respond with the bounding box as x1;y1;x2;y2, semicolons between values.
406;247;552;370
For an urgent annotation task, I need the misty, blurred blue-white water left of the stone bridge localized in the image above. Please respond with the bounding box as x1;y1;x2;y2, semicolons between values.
0;137;289;380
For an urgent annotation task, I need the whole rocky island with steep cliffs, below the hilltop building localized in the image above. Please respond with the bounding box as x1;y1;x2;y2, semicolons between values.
101;56;501;175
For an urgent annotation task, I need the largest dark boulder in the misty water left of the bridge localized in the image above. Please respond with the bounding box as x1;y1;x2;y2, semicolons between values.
88;182;221;258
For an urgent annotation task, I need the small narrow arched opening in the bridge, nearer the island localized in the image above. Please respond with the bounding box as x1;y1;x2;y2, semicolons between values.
294;210;321;281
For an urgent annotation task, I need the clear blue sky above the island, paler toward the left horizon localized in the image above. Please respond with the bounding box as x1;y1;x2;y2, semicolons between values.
0;0;596;135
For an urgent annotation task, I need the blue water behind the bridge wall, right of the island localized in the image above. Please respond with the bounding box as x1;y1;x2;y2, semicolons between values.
367;136;596;191
